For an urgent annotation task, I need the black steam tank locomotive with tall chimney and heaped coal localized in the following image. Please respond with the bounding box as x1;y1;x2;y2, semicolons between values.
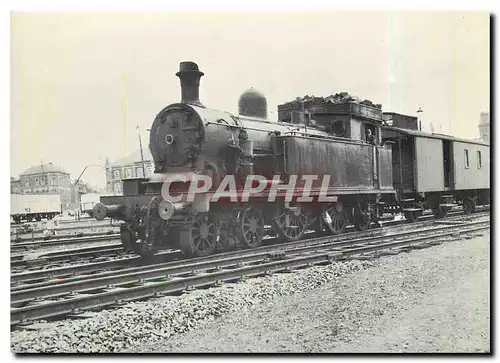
93;62;489;256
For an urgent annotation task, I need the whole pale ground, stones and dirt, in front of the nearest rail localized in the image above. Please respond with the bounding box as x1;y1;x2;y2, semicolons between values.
11;212;490;353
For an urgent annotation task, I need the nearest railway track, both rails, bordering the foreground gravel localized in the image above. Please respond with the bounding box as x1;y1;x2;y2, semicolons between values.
11;221;490;325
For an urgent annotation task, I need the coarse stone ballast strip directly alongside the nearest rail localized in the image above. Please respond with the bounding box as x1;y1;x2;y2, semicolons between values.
11;261;371;353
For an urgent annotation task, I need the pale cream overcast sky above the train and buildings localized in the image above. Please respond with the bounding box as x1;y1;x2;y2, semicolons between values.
11;11;490;185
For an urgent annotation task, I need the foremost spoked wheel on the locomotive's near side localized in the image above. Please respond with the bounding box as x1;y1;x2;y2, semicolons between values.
191;213;218;257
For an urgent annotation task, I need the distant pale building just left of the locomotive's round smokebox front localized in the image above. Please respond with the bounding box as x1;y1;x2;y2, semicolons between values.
106;148;154;195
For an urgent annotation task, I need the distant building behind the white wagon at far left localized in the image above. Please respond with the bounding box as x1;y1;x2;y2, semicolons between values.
17;163;71;210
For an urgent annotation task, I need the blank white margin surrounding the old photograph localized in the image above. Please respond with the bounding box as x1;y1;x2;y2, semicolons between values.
0;0;500;361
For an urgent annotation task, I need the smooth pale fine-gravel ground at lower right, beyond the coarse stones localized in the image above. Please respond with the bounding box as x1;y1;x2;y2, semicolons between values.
134;232;490;353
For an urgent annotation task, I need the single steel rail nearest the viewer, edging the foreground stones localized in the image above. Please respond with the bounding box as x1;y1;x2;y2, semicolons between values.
11;225;490;325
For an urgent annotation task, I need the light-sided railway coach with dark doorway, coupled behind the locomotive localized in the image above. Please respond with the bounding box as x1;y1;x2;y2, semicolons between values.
382;126;490;220
